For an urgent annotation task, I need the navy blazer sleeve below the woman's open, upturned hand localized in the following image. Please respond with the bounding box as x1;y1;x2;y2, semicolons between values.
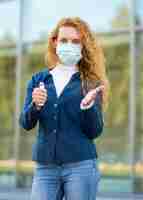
81;91;104;139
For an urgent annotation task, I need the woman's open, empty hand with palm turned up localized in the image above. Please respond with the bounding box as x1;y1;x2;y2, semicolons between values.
81;85;105;106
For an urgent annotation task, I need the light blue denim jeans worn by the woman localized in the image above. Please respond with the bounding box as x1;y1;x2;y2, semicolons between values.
31;158;101;200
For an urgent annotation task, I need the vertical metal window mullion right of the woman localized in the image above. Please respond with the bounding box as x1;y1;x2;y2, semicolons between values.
129;0;137;195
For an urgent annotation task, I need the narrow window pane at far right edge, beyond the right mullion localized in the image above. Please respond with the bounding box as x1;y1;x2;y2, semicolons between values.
134;33;143;192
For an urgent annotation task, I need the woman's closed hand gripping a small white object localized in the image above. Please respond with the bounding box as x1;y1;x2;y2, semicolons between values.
32;87;47;110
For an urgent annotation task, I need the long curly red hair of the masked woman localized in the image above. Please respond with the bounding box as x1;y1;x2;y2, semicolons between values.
45;17;109;109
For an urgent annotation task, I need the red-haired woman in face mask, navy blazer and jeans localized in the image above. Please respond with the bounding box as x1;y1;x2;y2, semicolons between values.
19;17;109;200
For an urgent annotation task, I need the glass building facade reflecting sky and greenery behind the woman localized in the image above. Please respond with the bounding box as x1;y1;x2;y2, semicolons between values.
0;0;143;193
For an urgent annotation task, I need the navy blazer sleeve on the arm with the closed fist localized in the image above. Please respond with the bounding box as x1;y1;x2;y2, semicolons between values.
19;76;40;130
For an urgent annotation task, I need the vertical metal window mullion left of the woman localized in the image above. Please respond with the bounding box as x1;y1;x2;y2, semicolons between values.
14;0;24;186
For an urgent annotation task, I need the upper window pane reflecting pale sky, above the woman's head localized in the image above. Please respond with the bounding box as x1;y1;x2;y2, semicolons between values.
25;0;129;39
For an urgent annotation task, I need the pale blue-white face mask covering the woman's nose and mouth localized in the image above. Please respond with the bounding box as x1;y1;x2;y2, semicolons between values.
56;42;82;65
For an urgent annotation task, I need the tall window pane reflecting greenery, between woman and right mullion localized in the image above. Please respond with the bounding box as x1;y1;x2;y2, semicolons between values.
95;34;132;192
